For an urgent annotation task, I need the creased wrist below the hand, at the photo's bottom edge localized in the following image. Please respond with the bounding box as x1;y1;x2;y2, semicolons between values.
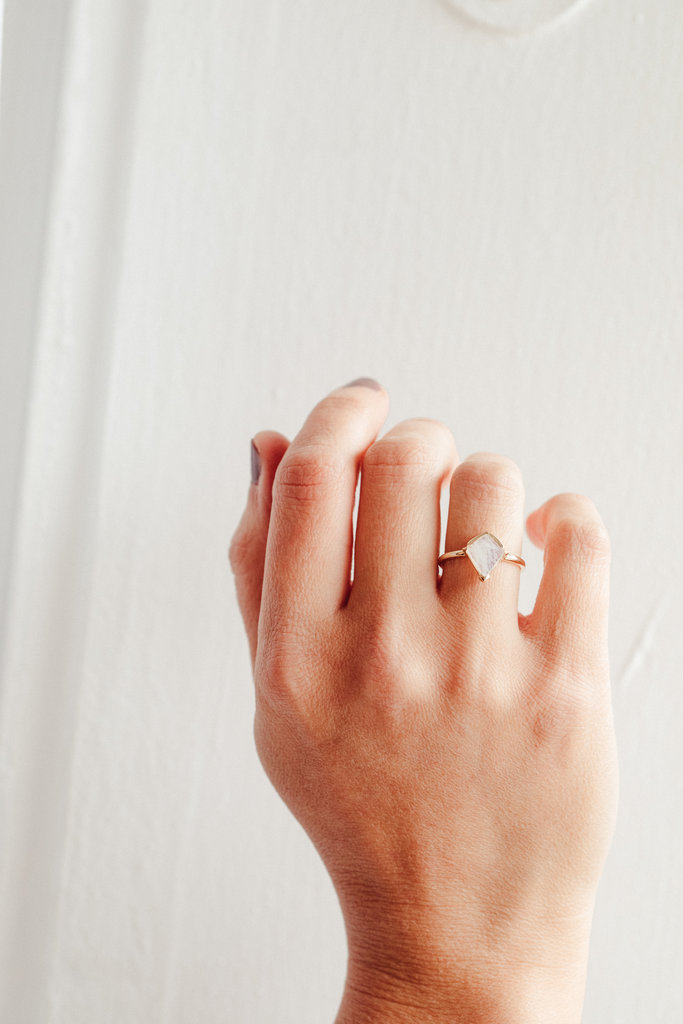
336;901;591;1024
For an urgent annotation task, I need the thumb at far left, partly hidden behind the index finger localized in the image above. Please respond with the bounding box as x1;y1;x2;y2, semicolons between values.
229;430;290;665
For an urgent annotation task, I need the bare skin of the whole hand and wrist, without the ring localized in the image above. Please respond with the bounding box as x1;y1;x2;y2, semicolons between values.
230;382;617;1024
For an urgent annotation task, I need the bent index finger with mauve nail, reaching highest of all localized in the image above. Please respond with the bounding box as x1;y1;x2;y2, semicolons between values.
264;381;389;628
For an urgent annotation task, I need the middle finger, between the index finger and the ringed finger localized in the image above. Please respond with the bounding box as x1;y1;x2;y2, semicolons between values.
349;419;458;605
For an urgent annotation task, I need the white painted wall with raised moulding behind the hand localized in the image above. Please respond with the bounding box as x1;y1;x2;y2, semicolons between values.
0;0;683;1024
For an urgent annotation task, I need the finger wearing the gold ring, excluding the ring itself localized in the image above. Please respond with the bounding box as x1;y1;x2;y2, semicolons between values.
440;453;524;624
